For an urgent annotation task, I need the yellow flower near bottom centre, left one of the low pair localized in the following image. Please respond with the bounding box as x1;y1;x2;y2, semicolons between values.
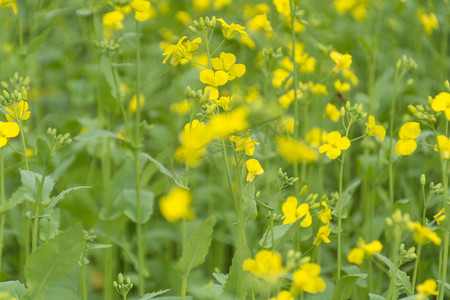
242;250;286;282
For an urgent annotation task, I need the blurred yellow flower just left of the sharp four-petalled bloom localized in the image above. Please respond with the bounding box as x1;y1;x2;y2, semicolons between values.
275;136;317;163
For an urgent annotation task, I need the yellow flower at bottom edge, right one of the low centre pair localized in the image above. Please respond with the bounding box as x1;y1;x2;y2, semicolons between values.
291;263;326;294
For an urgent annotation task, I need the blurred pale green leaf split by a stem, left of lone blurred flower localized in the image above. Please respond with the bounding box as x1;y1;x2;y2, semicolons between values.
122;190;154;224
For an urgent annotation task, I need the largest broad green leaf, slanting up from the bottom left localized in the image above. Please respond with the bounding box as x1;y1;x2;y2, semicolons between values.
24;224;84;299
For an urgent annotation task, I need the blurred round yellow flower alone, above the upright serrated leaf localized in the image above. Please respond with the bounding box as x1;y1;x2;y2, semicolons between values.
159;187;194;222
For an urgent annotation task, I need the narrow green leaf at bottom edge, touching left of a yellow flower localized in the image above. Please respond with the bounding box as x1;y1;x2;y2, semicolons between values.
225;245;252;299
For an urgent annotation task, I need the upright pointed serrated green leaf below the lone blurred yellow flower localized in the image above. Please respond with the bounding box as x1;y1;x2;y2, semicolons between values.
176;216;216;274
